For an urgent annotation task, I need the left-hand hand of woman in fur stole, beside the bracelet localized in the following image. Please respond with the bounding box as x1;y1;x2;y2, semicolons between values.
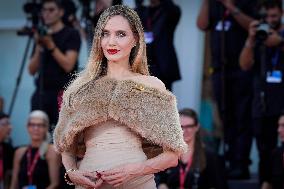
68;170;103;189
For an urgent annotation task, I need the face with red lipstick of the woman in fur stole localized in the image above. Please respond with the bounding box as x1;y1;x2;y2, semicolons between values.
101;15;136;62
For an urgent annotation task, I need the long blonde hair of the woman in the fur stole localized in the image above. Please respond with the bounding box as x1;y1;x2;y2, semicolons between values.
64;5;149;96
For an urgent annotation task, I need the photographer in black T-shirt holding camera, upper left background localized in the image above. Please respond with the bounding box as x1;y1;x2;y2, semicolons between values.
29;0;81;128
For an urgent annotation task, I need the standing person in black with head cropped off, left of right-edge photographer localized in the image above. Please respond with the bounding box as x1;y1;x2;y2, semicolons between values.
197;0;257;179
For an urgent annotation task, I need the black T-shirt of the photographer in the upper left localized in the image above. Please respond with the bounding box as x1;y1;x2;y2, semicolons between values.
35;27;81;91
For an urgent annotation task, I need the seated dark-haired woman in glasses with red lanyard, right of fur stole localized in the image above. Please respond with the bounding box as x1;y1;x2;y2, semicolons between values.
158;109;228;189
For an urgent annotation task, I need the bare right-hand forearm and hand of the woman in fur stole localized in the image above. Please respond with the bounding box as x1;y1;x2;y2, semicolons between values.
101;151;178;187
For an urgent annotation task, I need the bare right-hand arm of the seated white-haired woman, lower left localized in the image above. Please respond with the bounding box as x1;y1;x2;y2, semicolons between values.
46;145;60;189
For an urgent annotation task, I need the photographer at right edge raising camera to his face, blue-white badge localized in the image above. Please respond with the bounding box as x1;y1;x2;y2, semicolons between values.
240;0;284;186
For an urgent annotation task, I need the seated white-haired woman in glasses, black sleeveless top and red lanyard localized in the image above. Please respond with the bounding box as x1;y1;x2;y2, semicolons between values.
10;110;60;189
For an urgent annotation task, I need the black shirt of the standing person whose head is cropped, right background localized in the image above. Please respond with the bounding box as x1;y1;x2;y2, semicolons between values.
208;0;257;69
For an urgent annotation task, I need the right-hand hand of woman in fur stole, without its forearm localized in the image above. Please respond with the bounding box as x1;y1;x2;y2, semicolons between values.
101;163;143;187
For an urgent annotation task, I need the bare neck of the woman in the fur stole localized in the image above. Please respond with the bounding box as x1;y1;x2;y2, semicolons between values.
107;61;133;79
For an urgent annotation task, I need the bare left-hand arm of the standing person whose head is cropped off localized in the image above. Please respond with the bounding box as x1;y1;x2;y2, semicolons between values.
196;0;209;31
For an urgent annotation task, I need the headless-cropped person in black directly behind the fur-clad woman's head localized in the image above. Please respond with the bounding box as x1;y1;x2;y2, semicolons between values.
135;0;181;90
